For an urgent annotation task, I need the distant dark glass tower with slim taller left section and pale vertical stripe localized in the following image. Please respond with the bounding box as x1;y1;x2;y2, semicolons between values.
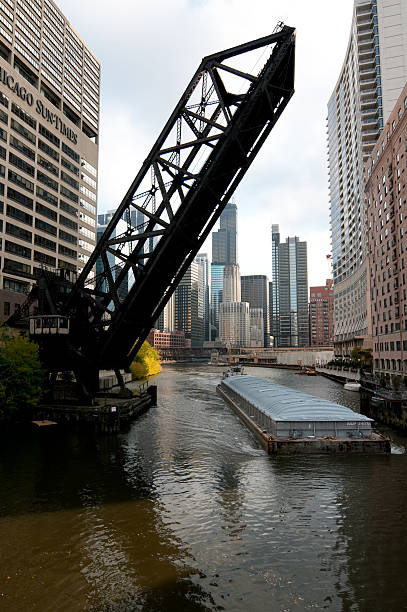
272;225;309;347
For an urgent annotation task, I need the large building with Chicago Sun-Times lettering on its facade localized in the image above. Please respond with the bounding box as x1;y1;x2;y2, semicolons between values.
0;0;100;320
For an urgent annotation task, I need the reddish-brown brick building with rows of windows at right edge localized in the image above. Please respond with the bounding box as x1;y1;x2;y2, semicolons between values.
365;79;407;377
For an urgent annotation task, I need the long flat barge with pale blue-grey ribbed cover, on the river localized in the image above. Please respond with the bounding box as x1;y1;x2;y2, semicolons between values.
217;376;390;455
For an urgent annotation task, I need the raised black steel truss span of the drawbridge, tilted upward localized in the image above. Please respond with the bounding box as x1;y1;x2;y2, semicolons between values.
50;26;295;376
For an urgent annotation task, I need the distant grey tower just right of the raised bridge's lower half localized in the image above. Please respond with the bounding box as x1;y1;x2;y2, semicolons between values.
174;261;204;348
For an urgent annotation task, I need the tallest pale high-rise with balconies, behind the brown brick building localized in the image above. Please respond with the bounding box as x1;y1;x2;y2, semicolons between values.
328;0;407;357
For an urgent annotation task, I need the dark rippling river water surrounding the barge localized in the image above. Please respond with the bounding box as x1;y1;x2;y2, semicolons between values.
0;364;407;612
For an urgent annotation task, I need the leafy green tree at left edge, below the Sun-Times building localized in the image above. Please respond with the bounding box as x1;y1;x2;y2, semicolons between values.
0;327;45;419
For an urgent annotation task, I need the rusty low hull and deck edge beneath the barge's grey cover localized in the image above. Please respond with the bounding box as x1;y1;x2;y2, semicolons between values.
217;381;391;455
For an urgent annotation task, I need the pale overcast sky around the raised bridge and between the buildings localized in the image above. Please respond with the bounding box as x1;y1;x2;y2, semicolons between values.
57;0;353;285
